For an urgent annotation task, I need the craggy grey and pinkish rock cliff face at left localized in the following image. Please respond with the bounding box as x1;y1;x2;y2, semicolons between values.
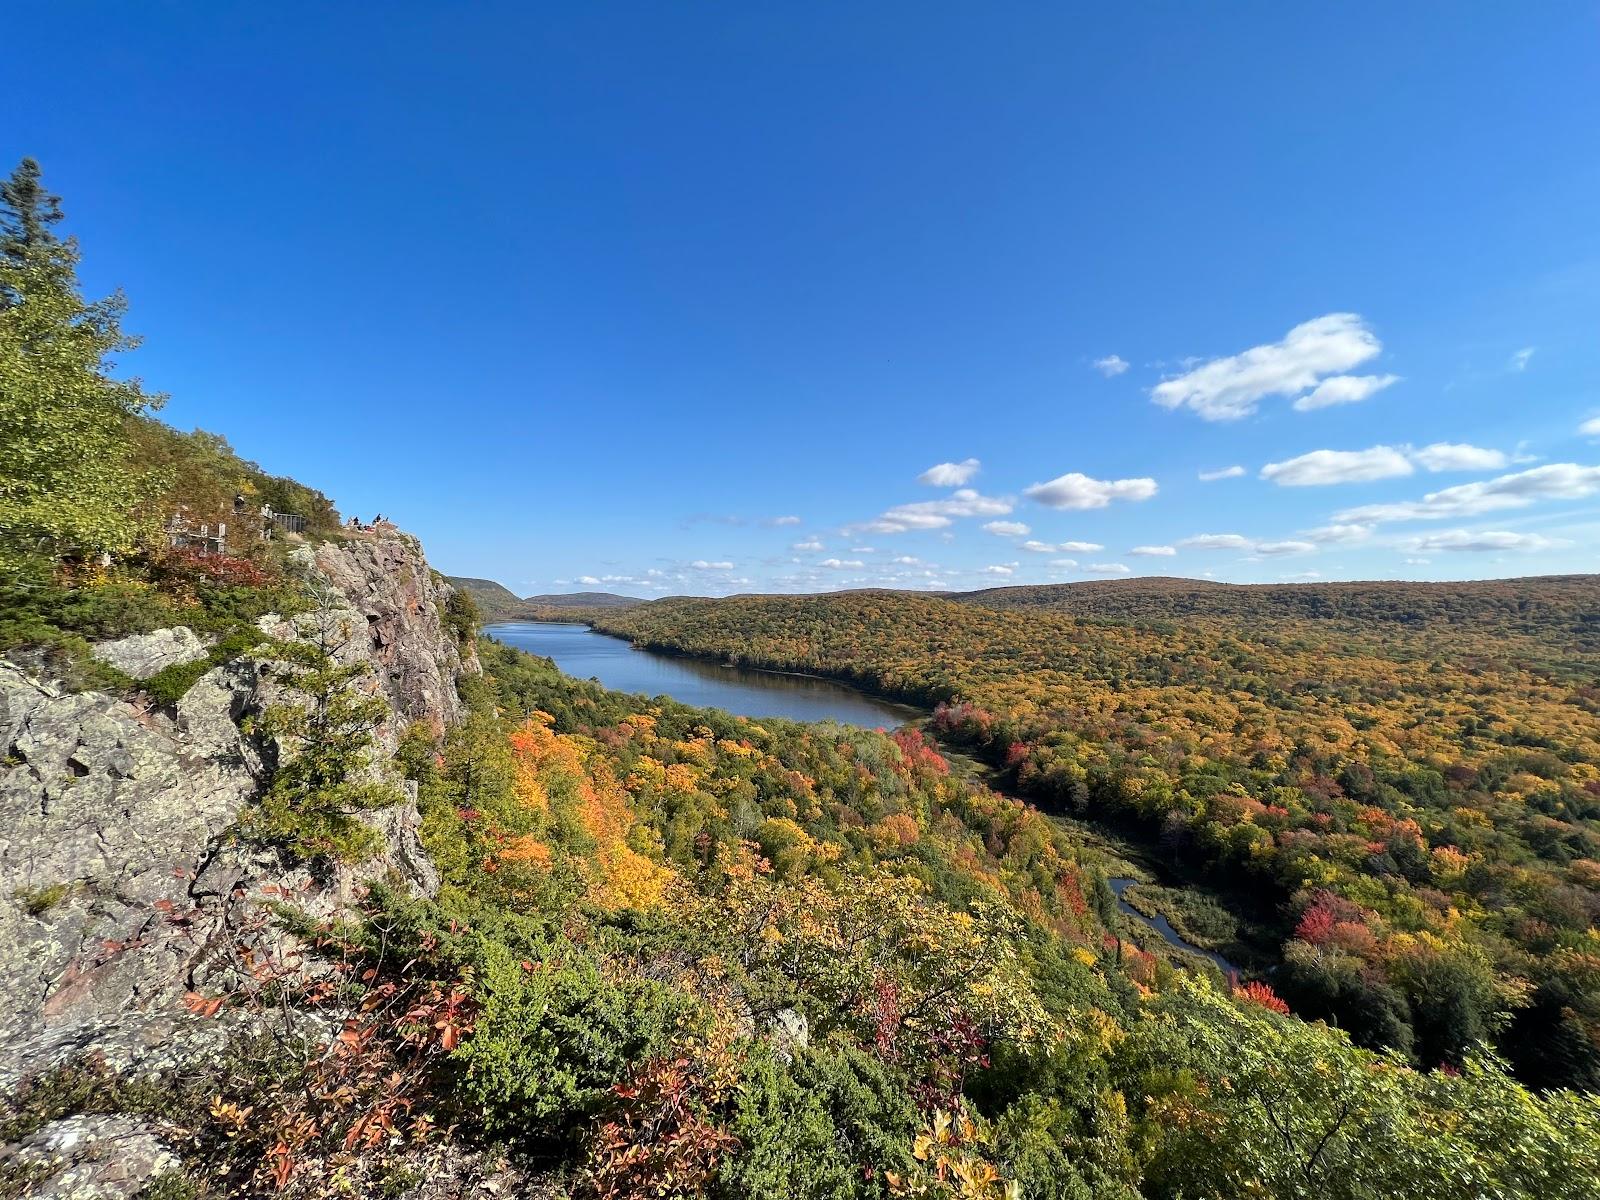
0;533;477;1107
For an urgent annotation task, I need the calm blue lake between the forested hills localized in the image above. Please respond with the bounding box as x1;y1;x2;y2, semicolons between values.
483;621;922;730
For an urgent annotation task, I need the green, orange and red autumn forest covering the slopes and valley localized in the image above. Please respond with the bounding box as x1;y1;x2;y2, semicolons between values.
0;150;1600;1200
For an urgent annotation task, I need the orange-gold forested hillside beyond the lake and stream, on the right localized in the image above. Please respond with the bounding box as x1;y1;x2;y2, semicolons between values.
600;578;1600;1088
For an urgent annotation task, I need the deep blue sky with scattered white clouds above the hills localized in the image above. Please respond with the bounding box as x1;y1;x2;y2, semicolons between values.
12;3;1600;595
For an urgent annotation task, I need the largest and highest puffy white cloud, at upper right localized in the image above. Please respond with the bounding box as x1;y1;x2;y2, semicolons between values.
1150;312;1384;421
